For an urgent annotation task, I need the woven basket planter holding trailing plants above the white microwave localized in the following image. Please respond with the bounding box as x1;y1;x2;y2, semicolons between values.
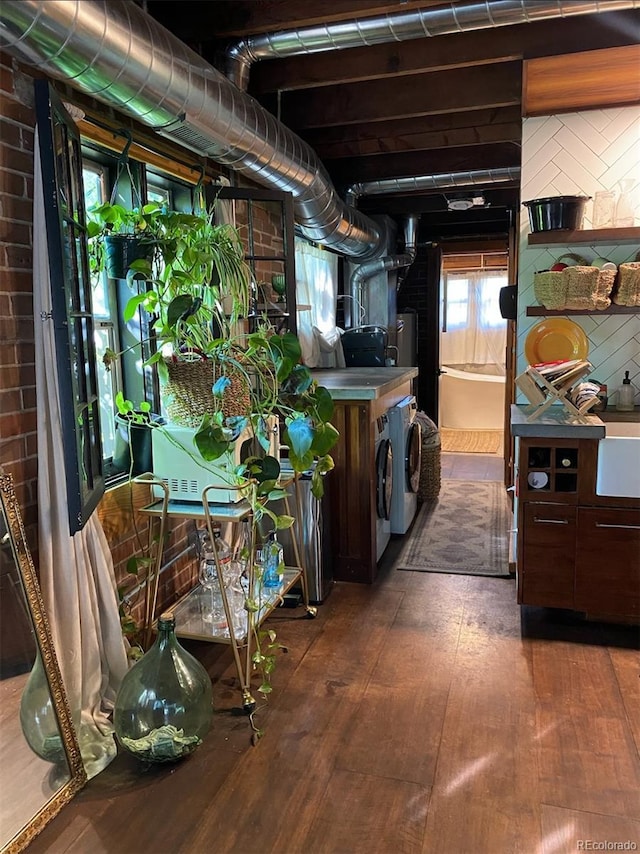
164;359;251;428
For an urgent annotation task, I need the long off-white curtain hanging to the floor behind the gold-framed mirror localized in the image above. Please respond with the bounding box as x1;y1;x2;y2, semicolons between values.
33;135;127;777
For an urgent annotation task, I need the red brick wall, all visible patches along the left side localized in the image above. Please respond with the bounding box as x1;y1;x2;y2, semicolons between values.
0;56;281;644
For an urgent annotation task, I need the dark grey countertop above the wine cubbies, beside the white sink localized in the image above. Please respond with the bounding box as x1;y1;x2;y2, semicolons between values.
511;404;640;439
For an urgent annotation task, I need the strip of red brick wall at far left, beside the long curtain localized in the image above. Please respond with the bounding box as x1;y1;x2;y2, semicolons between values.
0;51;37;552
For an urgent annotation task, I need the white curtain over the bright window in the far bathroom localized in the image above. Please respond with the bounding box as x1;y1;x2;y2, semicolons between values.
440;270;507;375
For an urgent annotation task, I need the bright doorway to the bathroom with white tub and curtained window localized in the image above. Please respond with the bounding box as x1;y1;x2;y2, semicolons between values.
438;252;509;458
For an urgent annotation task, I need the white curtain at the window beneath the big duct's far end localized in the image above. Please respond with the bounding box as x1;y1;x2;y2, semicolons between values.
295;238;345;368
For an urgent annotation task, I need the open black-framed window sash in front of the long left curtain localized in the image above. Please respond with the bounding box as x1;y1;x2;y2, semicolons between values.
35;80;104;534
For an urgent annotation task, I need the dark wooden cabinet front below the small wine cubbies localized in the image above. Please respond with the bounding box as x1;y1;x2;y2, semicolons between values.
518;502;577;608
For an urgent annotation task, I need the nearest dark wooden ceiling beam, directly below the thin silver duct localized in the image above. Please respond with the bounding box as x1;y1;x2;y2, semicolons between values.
250;10;640;96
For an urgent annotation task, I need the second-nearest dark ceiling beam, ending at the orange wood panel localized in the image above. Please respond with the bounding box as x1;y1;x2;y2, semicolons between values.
281;62;522;131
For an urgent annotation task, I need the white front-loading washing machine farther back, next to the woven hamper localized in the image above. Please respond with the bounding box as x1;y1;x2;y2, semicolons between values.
389;395;422;534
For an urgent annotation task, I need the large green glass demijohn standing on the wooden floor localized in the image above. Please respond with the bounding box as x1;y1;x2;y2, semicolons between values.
113;611;213;762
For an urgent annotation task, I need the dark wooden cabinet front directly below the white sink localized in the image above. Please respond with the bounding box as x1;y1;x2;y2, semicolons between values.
575;507;640;617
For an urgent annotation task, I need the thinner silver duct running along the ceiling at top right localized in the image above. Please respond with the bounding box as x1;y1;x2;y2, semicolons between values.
227;0;640;90
